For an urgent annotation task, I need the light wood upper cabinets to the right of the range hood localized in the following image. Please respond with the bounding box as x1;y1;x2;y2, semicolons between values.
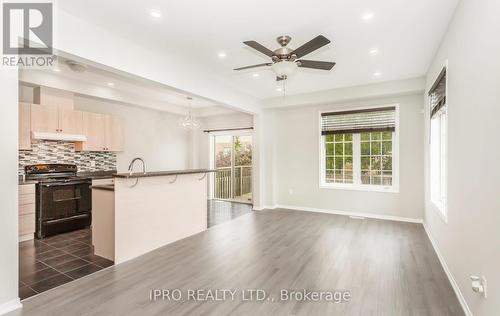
75;112;123;151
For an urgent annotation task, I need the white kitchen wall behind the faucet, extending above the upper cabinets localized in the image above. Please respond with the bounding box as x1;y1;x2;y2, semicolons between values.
75;96;190;172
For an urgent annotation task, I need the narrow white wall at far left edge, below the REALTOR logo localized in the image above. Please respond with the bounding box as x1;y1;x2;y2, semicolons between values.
0;68;20;314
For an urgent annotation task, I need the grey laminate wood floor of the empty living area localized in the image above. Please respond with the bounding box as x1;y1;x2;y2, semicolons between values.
9;210;463;316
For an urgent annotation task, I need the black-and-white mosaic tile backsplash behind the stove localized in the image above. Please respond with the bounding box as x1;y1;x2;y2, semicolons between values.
18;140;116;175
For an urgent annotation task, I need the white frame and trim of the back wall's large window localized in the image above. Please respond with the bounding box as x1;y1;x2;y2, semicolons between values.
317;103;399;193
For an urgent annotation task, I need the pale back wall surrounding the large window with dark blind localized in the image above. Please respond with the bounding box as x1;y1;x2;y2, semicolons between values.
266;94;424;219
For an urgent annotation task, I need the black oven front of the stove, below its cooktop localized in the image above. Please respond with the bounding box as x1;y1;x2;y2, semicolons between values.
36;180;92;238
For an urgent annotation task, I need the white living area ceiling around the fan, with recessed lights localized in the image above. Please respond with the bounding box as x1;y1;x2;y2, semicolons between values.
58;0;459;99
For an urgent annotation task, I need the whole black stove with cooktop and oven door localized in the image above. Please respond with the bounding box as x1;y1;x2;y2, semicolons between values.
24;164;92;238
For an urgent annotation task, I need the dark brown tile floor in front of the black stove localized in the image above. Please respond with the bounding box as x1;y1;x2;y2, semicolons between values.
19;229;113;299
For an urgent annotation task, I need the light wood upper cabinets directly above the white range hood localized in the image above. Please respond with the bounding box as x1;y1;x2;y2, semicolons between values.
31;104;83;135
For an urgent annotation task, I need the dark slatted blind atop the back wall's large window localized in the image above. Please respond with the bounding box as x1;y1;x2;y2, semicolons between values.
321;107;396;135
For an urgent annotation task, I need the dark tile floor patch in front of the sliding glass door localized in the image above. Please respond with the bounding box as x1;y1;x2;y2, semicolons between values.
207;200;252;227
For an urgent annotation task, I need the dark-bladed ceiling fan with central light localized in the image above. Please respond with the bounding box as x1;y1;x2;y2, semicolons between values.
234;35;335;81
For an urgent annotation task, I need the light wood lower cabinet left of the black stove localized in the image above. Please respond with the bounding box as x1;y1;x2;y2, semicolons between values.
19;184;35;241
